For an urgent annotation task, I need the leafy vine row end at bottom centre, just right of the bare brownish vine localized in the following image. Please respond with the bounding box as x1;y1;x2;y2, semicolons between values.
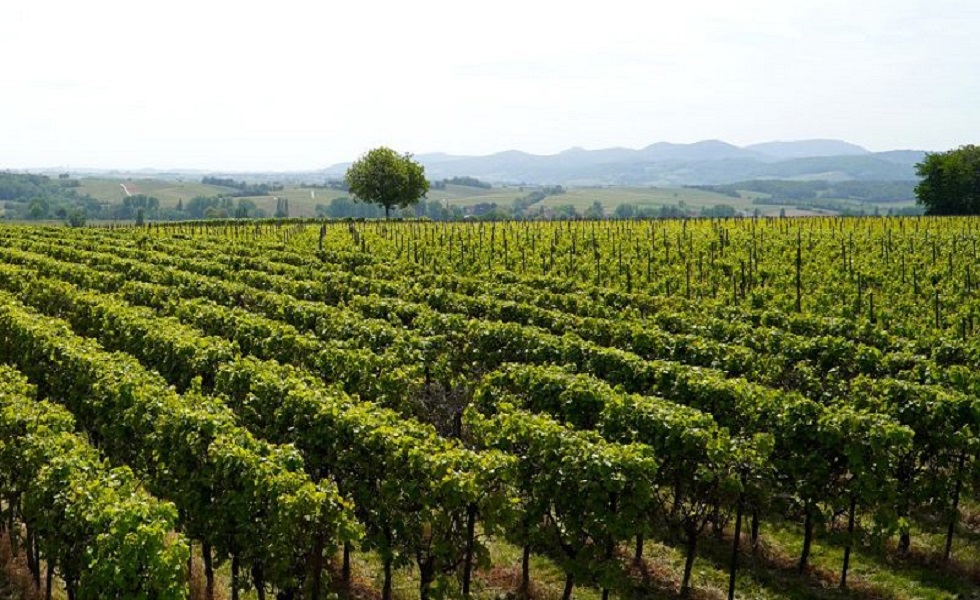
465;408;658;585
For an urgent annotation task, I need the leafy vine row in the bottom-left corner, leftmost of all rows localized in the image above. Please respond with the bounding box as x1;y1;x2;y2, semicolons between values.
0;366;188;600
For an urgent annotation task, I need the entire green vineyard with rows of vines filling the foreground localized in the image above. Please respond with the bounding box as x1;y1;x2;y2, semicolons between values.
0;218;980;600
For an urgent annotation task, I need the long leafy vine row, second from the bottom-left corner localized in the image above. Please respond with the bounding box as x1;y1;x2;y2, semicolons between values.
0;293;359;595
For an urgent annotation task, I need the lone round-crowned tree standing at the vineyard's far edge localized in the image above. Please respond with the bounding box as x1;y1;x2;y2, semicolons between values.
344;146;429;219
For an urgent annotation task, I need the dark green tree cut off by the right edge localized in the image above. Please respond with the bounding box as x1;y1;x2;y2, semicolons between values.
915;144;980;215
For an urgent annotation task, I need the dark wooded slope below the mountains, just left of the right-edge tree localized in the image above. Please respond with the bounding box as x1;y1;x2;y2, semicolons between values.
687;179;915;204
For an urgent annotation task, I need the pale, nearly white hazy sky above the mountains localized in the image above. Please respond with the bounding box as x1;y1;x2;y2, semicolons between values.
0;0;980;170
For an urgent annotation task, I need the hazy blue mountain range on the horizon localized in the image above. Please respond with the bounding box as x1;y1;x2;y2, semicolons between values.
323;140;925;186
